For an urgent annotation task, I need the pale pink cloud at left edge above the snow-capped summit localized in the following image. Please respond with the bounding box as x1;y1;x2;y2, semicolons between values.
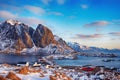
0;10;18;19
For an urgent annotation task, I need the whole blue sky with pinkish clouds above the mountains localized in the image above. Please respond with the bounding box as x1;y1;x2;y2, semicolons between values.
0;0;120;49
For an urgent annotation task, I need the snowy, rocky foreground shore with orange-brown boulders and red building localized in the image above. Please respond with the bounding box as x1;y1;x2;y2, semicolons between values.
0;59;120;80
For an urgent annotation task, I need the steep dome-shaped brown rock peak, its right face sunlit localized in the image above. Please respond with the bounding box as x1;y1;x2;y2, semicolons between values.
33;24;57;48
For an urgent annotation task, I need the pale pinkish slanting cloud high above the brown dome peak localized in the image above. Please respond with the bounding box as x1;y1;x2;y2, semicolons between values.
24;5;45;15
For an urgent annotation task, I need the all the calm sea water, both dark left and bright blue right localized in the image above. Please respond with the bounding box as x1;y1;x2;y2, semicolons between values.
0;54;120;68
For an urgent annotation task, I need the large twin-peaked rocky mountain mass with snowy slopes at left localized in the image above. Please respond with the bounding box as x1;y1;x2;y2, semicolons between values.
0;19;73;54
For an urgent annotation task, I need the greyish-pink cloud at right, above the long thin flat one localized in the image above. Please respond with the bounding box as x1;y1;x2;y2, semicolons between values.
84;21;110;27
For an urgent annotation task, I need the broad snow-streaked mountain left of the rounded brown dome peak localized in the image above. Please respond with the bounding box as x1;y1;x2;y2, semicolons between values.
0;20;33;51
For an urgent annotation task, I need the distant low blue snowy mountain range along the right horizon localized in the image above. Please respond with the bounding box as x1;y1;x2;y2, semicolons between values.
67;42;120;54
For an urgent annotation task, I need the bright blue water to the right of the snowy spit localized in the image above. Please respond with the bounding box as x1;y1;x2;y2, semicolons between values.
55;56;120;68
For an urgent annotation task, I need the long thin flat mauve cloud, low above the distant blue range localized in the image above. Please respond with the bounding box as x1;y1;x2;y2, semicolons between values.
74;34;104;39
